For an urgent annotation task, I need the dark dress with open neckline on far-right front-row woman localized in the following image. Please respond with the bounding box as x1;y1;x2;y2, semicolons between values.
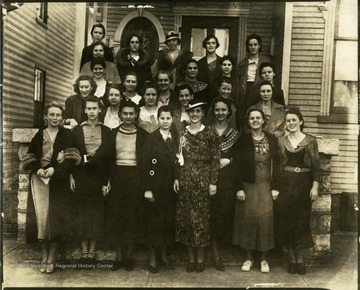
275;135;320;249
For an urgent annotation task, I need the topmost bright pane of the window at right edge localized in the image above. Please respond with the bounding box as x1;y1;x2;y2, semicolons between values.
338;0;358;38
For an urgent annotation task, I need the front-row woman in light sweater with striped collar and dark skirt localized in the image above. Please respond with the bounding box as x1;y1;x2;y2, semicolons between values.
107;101;148;271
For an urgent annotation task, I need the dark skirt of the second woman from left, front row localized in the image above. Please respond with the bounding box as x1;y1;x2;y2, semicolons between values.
74;166;105;241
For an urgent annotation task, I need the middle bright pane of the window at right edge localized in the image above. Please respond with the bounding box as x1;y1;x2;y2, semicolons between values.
335;41;358;81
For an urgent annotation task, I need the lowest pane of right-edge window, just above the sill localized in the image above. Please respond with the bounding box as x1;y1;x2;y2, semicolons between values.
333;81;358;114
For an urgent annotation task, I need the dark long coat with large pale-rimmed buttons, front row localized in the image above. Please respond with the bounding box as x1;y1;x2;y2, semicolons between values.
142;129;178;246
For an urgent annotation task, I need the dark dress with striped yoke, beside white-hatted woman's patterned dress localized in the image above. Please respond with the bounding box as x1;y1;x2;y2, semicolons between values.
210;125;240;244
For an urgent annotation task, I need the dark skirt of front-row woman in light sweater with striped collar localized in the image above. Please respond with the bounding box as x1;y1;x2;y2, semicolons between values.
106;166;144;245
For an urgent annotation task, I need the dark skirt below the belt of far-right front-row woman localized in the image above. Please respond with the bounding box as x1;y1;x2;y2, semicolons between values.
274;171;314;249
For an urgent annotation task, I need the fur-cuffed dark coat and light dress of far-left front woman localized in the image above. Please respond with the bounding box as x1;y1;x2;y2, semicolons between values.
21;127;72;242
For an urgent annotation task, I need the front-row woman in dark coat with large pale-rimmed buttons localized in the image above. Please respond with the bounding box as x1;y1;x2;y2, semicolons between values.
142;106;178;273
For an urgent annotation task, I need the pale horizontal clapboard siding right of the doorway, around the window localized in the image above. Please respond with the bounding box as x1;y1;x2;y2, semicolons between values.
289;2;358;193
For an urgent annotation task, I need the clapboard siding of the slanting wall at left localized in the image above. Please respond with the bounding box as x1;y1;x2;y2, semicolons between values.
2;3;76;190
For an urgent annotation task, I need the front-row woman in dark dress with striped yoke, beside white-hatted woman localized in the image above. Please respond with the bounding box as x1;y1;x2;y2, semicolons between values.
210;97;240;271
